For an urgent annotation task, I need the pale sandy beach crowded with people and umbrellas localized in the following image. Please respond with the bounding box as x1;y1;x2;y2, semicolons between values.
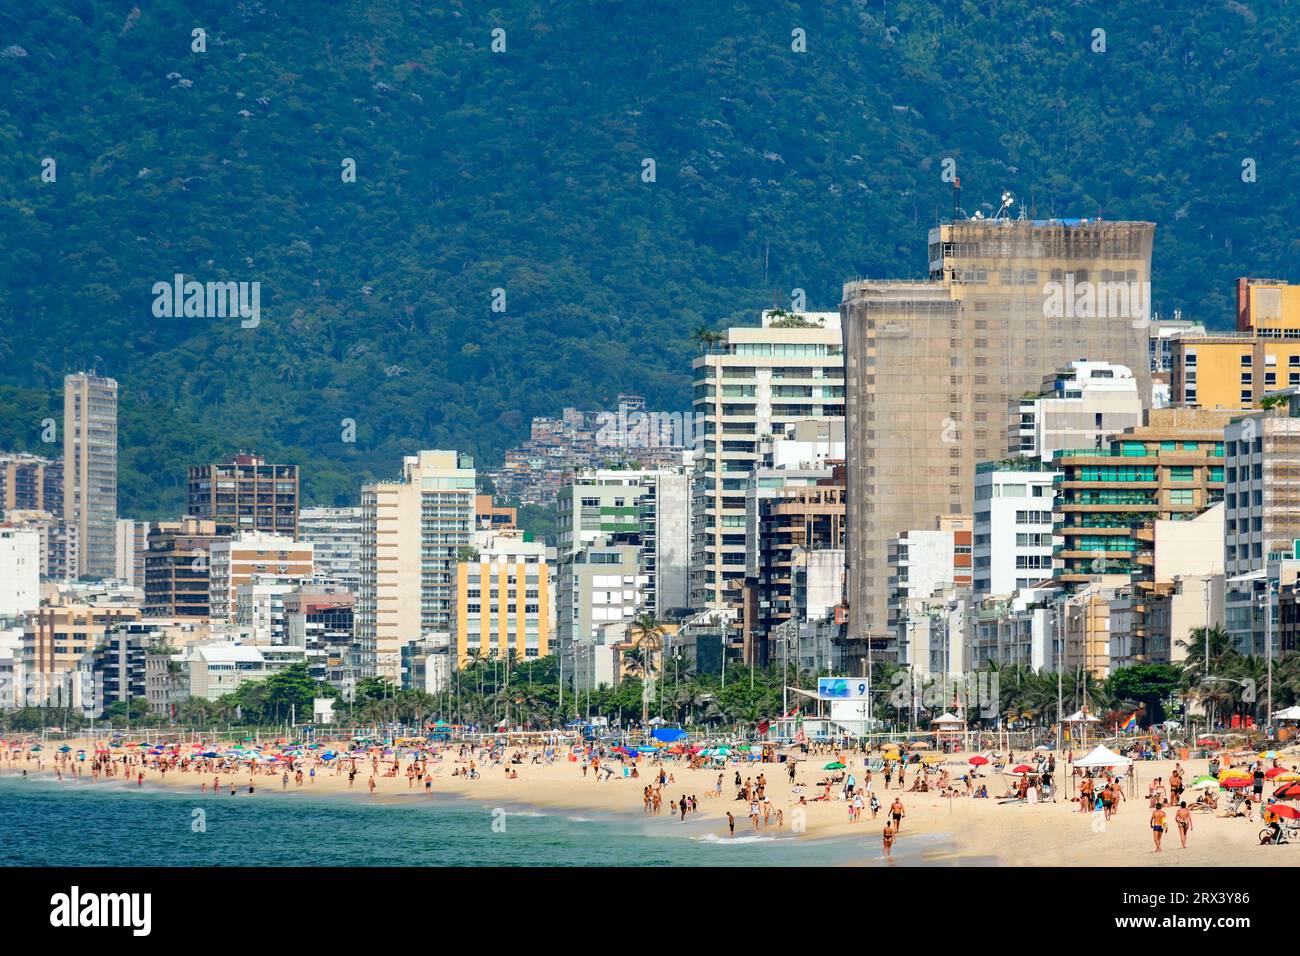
0;740;1300;866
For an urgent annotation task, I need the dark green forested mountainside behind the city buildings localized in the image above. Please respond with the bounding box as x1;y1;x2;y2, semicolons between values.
0;0;1300;516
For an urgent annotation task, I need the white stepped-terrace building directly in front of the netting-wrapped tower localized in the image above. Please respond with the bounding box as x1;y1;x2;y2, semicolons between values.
1008;362;1143;463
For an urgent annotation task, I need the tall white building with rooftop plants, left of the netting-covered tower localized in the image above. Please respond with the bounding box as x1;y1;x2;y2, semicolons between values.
690;312;844;607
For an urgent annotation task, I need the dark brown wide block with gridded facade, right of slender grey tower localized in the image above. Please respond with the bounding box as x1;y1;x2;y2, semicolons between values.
186;453;298;537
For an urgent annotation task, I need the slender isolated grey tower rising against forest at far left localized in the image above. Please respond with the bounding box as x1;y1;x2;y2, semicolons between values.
64;372;117;579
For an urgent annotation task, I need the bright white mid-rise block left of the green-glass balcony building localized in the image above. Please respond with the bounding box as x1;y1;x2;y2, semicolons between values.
971;459;1057;601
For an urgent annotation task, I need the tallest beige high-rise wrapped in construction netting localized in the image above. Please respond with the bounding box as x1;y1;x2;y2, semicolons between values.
840;219;1156;667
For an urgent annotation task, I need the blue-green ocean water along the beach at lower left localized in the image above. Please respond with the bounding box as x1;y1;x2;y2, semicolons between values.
0;775;943;866
